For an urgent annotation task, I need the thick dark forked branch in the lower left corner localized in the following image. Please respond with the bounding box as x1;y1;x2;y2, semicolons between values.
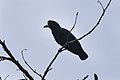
0;40;34;80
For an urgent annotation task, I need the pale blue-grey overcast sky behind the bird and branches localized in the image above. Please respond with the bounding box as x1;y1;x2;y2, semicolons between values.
0;0;120;80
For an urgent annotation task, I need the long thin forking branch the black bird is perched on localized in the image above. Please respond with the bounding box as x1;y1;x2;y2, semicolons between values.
41;0;112;80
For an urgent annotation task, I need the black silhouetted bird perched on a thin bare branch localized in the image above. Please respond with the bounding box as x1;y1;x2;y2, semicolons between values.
44;20;88;60
